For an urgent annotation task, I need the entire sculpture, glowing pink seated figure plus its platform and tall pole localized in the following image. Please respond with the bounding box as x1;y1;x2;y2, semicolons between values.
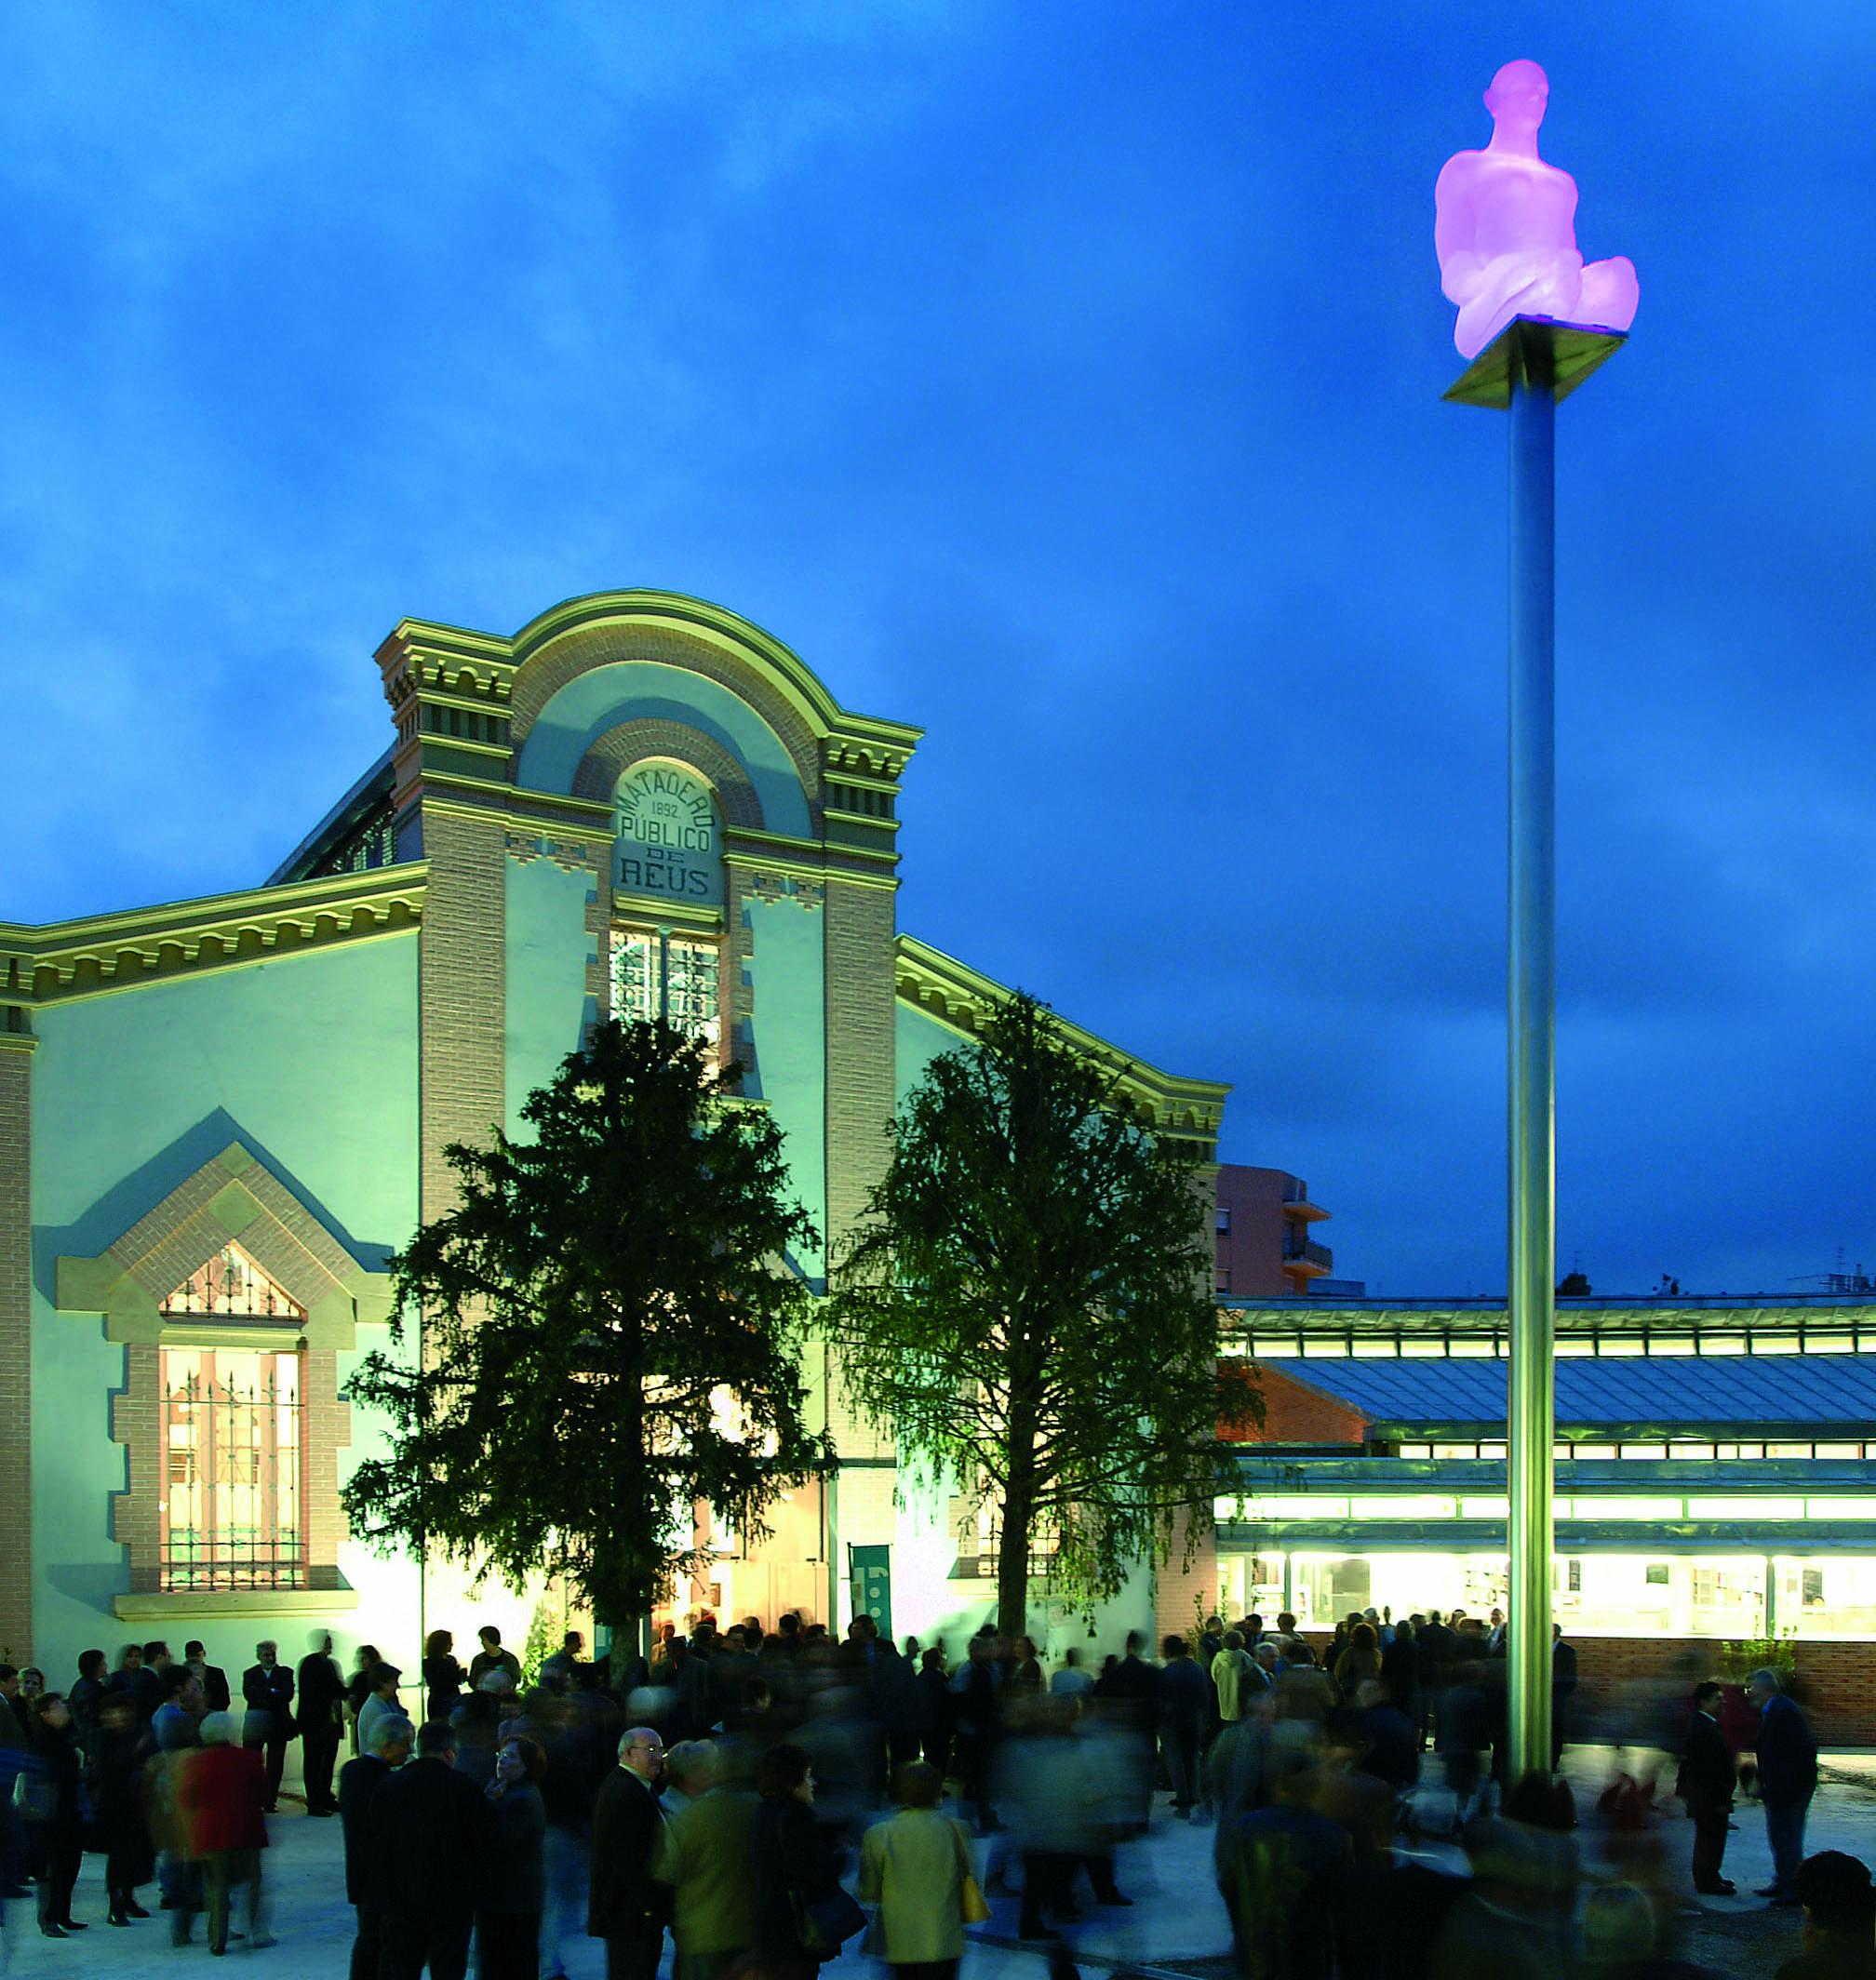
1434;61;1641;1780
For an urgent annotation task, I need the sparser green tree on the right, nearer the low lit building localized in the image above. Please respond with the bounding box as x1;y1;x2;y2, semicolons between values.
828;996;1262;1629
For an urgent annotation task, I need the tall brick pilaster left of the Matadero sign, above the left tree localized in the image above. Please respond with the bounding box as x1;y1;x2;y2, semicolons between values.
418;798;507;1224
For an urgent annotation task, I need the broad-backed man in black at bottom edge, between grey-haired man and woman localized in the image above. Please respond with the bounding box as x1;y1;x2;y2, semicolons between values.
366;1719;495;1980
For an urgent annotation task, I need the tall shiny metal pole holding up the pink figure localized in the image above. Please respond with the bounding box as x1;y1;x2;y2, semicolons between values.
1506;323;1557;1782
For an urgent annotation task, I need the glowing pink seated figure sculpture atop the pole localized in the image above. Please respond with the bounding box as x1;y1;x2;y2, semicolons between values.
1432;61;1642;358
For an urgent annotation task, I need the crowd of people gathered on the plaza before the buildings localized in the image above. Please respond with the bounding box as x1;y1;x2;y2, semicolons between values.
0;1610;1876;1980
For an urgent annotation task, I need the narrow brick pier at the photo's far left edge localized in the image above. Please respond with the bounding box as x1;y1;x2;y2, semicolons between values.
0;1008;32;1664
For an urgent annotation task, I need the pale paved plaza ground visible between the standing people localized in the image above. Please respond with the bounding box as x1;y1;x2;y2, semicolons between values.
4;1748;1876;1980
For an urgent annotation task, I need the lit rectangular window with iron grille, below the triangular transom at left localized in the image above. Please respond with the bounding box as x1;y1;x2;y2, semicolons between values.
158;1348;307;1590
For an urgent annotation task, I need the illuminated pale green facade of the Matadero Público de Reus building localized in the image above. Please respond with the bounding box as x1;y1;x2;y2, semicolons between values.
0;592;1225;1673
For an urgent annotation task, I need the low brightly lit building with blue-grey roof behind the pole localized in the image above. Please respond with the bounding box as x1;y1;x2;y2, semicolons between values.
1209;1295;1876;1731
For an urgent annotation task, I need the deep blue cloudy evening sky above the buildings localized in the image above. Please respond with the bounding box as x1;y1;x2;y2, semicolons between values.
0;0;1876;1293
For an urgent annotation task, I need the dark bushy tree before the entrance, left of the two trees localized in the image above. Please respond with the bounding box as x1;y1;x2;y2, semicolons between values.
344;1023;824;1647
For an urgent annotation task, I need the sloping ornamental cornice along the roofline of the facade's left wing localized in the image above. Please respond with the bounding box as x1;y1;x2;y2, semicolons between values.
0;862;430;1004
